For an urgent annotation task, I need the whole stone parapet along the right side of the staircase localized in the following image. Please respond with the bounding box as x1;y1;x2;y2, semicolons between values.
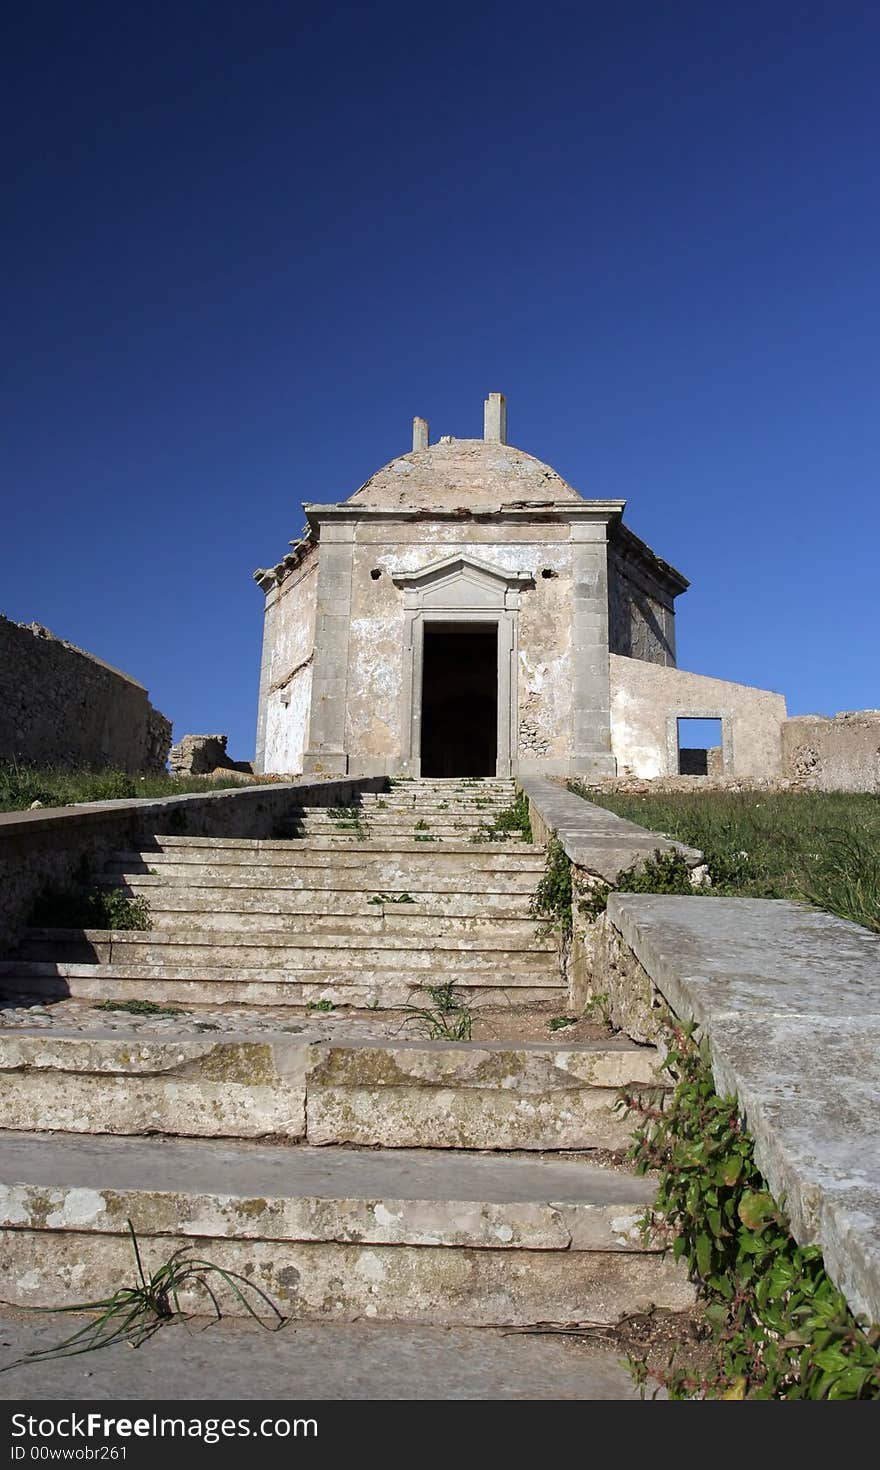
522;779;880;1322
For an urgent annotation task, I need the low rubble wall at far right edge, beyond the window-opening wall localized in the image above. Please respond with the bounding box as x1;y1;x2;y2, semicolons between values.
782;710;880;791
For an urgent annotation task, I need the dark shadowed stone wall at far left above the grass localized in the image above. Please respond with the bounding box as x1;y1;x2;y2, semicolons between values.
0;616;170;772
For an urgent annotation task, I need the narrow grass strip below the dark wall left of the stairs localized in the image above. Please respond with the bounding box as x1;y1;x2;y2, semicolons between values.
0;761;268;811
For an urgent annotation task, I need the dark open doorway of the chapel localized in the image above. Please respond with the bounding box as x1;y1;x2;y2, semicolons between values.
422;623;498;776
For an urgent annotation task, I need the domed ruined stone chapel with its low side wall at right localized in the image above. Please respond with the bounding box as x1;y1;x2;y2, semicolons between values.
254;392;786;778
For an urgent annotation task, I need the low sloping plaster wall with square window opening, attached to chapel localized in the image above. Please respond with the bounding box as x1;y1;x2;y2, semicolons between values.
611;654;786;779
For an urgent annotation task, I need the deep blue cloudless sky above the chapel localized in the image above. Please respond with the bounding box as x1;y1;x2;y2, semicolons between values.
0;0;880;759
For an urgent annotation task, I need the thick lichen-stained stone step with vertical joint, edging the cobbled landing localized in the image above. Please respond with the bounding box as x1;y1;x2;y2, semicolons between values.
0;1016;660;1151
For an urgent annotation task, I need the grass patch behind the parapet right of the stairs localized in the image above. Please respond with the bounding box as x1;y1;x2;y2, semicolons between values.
570;782;880;932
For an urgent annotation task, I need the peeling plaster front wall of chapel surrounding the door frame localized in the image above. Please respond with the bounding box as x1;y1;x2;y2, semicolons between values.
345;522;573;770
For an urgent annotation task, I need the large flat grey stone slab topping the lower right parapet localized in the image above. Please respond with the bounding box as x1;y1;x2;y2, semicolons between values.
608;894;880;1322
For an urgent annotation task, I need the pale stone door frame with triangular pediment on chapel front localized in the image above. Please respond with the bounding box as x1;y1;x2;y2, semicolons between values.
394;556;535;776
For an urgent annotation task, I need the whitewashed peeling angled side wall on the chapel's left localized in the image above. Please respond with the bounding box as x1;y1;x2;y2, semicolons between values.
254;548;319;776
